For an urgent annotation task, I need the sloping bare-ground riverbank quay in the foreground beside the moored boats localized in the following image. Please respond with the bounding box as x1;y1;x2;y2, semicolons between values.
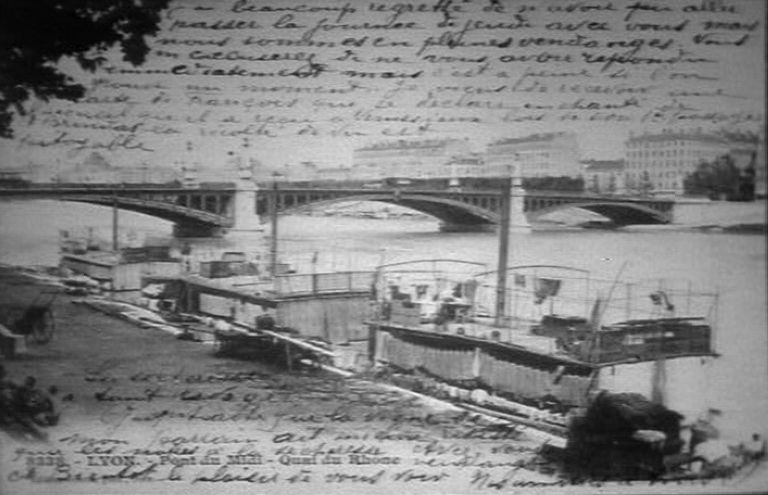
0;268;766;494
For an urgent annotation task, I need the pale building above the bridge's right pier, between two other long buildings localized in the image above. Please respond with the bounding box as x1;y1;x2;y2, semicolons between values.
485;132;582;178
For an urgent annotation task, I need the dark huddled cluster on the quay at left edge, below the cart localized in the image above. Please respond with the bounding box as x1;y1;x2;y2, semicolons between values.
0;364;59;437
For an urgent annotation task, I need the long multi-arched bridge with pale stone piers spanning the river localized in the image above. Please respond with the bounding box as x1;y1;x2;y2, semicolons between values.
0;183;674;237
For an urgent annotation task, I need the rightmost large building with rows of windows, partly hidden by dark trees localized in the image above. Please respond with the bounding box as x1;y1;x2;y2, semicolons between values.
625;129;759;194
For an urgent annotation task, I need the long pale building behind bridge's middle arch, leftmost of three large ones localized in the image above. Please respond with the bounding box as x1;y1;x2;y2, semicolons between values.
352;139;471;180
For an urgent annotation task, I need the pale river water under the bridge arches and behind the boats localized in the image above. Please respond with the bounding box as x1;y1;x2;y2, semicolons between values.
0;201;768;444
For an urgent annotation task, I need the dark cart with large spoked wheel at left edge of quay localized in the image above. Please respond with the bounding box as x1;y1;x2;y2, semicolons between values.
0;290;59;357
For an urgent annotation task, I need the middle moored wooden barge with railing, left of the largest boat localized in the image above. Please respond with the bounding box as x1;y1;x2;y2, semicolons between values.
144;272;374;368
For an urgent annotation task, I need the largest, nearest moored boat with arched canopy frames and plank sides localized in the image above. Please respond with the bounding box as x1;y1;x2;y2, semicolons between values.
368;260;717;476
